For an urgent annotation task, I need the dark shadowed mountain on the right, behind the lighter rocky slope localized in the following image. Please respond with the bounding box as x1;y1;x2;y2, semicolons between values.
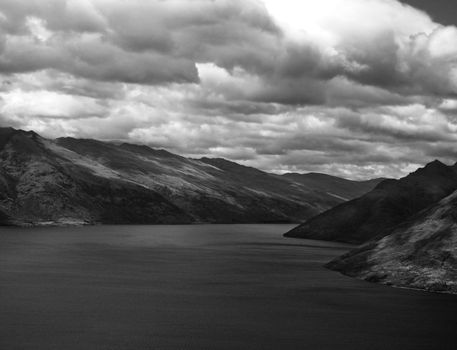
286;161;457;243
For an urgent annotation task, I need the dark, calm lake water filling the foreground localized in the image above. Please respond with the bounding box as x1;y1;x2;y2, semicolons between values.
0;225;457;350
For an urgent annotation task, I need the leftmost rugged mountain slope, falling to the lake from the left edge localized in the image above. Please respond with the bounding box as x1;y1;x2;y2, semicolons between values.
0;129;191;224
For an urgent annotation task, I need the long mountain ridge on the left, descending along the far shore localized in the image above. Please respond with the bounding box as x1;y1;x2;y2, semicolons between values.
0;128;378;224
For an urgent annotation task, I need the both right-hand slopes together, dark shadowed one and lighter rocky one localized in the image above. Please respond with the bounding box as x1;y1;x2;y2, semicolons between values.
286;161;457;293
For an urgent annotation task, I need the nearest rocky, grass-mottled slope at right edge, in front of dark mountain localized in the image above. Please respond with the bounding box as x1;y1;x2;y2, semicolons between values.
327;191;457;293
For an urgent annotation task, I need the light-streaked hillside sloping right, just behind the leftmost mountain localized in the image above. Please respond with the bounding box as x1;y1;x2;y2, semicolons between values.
54;138;318;223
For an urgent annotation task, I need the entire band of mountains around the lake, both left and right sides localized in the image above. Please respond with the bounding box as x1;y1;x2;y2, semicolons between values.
0;128;457;293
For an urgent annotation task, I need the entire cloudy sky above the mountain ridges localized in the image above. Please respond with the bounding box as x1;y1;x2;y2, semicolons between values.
0;0;457;179
